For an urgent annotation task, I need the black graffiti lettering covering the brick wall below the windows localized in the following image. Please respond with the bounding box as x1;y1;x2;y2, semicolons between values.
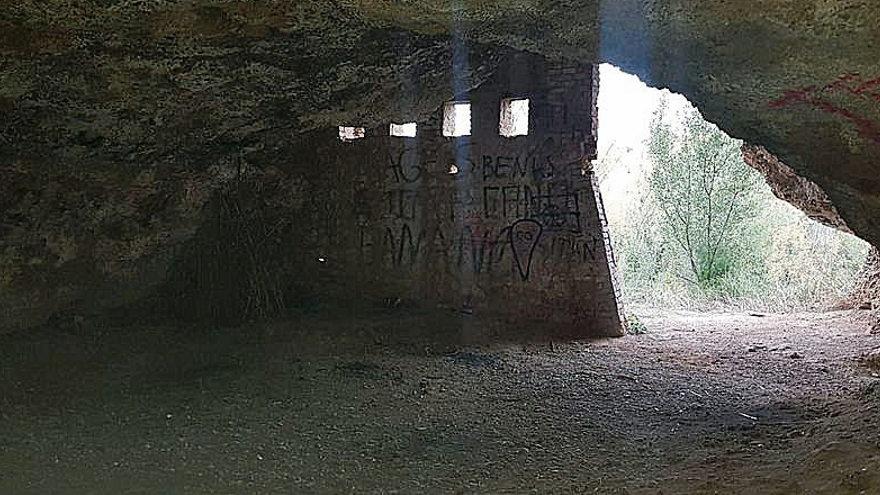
359;144;604;281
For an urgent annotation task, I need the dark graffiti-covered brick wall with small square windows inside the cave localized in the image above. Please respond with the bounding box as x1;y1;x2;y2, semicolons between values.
292;56;623;335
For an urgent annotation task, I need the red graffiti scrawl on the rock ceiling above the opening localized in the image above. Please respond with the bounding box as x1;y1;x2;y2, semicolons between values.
770;74;880;144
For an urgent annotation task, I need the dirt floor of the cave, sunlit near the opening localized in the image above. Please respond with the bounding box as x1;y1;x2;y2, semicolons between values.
0;309;880;495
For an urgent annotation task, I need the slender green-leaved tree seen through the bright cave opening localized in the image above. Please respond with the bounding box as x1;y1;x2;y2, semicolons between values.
647;98;761;289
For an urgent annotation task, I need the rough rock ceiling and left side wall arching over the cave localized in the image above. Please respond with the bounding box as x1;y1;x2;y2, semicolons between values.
0;0;880;329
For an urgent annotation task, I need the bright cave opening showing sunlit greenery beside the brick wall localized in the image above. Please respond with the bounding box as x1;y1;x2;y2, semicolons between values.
595;64;869;312
